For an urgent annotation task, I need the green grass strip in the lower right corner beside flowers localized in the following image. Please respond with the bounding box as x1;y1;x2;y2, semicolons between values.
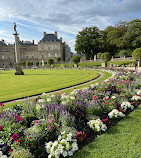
72;105;141;158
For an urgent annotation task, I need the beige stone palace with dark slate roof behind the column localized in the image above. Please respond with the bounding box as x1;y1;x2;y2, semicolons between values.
0;32;71;68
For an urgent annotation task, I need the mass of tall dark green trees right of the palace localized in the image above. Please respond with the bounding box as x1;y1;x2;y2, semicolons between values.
75;19;141;59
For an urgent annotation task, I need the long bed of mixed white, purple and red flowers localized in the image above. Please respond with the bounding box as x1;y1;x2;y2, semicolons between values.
0;70;141;158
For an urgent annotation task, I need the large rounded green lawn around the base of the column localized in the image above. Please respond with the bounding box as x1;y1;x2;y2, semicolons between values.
0;69;99;102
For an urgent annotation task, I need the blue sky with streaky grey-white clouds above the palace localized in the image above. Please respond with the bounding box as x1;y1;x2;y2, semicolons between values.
0;0;141;52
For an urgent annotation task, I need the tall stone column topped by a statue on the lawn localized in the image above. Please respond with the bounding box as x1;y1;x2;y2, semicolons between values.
13;23;24;75
